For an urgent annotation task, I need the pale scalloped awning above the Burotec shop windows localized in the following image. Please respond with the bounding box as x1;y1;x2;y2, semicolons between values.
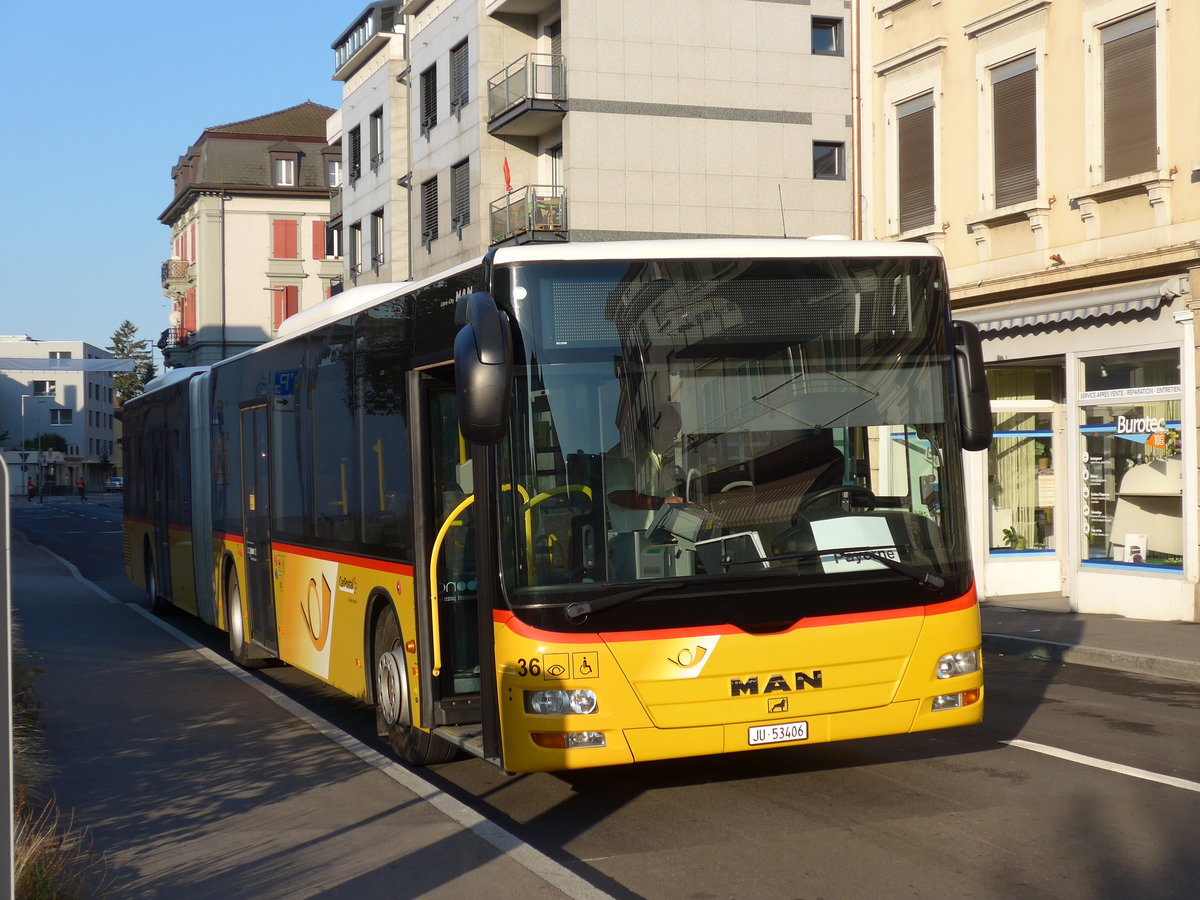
954;277;1187;331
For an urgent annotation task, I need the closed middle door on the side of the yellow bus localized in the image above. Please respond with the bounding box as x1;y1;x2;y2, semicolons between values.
241;406;278;654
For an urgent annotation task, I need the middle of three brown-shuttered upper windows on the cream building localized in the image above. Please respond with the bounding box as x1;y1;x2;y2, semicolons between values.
991;53;1038;208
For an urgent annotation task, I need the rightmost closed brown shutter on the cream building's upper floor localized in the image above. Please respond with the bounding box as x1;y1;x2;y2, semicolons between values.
1103;11;1158;181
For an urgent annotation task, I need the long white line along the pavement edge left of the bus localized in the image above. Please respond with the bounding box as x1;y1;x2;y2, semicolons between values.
32;547;612;900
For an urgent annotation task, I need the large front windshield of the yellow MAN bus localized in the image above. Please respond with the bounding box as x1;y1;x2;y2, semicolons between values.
497;258;967;607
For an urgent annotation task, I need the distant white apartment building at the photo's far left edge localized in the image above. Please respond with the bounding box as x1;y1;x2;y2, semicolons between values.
0;335;119;493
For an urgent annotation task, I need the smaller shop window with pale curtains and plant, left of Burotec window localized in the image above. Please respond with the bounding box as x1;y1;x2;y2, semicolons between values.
988;413;1056;553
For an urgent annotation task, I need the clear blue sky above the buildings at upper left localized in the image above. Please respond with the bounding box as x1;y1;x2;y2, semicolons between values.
0;0;348;359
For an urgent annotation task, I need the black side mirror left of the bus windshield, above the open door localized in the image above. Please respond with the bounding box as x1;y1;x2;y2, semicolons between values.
454;292;512;444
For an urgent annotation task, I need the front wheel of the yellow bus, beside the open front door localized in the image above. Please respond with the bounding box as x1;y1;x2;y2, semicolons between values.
372;605;458;766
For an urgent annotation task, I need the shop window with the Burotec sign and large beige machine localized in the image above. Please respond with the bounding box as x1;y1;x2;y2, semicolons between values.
1080;350;1183;569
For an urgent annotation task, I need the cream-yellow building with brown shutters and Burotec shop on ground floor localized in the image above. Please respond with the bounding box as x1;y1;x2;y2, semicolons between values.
859;0;1200;620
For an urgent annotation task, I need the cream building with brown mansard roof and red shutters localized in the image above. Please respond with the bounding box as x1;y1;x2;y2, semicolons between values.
158;102;343;366
